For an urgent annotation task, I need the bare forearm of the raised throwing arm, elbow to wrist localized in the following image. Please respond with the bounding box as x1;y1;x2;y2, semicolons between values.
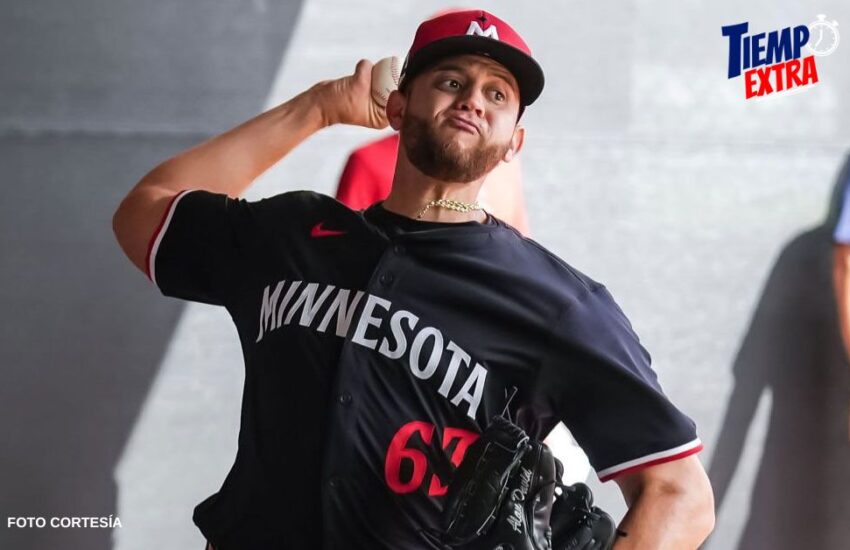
134;84;327;197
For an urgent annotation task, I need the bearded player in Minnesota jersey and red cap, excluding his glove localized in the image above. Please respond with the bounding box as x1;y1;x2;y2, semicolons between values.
113;10;713;550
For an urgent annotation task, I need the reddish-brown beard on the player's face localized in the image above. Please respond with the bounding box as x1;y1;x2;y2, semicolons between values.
401;111;510;183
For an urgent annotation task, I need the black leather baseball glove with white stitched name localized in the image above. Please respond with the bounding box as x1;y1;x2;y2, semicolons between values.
425;416;616;550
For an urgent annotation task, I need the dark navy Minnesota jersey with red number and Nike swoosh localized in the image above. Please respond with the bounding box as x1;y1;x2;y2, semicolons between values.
148;190;701;550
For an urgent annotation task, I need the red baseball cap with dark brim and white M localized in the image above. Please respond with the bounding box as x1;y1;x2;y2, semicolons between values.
399;10;543;109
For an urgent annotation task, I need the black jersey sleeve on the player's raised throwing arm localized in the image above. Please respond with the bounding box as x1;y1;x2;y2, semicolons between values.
147;190;257;305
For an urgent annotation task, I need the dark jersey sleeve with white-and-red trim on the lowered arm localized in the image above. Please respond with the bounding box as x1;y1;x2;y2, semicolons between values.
538;286;702;481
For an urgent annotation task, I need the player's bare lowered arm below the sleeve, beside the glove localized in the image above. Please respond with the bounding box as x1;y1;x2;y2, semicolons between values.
614;455;714;550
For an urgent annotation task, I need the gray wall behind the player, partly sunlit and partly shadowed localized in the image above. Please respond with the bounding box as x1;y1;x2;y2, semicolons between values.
0;0;850;550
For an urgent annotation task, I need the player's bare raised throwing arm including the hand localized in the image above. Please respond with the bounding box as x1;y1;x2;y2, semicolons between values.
112;60;387;273
